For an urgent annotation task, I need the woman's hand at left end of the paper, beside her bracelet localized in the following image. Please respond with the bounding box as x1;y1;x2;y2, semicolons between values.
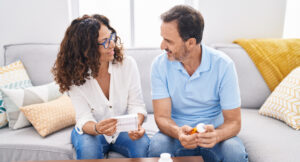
95;118;117;136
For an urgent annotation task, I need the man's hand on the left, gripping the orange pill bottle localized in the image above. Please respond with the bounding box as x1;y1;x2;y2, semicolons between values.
178;125;197;149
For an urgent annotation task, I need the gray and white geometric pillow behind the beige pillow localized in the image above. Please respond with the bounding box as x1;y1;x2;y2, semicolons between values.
0;82;62;129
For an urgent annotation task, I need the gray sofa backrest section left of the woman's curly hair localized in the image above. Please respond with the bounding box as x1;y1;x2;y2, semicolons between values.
3;43;59;85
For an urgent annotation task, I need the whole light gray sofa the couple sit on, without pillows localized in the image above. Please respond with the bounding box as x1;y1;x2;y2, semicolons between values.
0;44;300;162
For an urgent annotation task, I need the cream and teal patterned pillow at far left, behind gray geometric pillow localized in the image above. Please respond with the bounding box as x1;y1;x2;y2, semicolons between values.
0;61;32;128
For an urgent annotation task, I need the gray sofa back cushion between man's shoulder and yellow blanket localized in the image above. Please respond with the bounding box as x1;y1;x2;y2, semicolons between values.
212;44;271;109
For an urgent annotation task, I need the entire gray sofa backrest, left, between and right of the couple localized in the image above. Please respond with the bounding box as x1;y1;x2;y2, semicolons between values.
1;43;270;113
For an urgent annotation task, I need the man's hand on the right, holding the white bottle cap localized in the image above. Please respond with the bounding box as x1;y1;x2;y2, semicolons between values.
195;125;218;148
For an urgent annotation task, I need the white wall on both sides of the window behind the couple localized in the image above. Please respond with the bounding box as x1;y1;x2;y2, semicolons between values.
0;0;286;57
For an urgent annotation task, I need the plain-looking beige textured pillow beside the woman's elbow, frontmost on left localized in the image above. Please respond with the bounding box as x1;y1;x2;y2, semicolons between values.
20;95;75;137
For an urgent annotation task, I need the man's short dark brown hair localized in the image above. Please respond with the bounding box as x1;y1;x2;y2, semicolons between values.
160;5;204;44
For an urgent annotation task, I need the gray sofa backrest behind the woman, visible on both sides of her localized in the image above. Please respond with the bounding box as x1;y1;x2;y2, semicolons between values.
1;43;161;113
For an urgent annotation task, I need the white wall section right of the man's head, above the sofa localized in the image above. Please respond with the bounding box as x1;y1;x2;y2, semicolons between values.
199;0;286;44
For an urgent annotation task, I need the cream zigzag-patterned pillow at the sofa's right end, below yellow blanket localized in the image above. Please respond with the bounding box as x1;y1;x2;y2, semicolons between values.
259;67;300;130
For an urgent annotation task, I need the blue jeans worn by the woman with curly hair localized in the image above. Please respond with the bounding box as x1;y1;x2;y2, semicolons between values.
71;129;150;159
